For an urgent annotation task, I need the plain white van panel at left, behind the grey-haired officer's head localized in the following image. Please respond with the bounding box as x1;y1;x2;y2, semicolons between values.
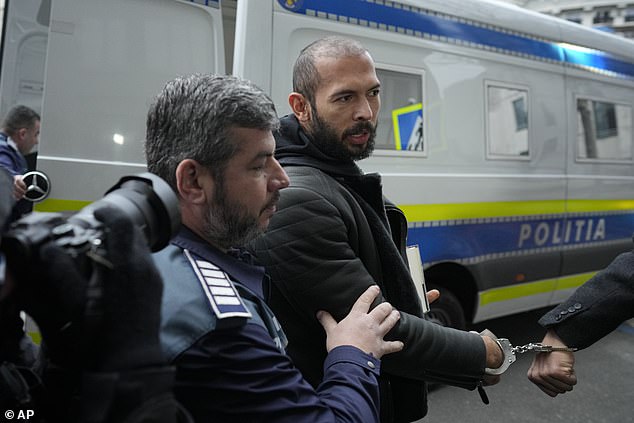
38;0;225;205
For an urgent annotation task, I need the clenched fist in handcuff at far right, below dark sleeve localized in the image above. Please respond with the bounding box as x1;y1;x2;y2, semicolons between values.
527;329;577;397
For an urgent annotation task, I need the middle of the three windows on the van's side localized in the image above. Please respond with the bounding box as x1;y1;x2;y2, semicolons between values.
485;82;530;159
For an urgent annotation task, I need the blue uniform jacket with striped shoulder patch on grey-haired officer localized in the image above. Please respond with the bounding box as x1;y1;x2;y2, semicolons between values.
155;228;380;423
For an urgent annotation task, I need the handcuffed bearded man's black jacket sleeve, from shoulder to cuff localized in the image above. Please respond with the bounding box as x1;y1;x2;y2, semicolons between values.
256;190;487;388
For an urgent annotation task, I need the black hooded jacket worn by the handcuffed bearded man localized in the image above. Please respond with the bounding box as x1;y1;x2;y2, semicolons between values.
254;116;485;421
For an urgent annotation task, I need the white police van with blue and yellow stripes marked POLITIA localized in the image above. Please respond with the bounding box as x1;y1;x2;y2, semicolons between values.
0;0;634;327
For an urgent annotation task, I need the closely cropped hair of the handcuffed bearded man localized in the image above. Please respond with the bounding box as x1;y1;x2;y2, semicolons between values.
293;35;368;108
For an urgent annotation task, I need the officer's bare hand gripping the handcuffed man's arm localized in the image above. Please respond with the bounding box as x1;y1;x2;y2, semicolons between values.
317;285;404;358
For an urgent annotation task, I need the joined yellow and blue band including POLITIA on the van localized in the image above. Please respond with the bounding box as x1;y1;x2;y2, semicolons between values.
400;200;634;266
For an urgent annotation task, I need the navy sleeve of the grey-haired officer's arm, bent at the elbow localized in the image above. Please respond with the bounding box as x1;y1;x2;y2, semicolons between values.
175;324;379;423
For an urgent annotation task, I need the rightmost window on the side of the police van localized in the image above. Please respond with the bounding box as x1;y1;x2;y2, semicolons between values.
577;98;632;161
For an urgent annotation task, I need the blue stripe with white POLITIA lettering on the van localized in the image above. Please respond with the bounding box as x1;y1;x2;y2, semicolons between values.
408;213;634;264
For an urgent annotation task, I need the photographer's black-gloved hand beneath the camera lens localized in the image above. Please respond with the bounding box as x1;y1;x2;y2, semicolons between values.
95;207;164;372
